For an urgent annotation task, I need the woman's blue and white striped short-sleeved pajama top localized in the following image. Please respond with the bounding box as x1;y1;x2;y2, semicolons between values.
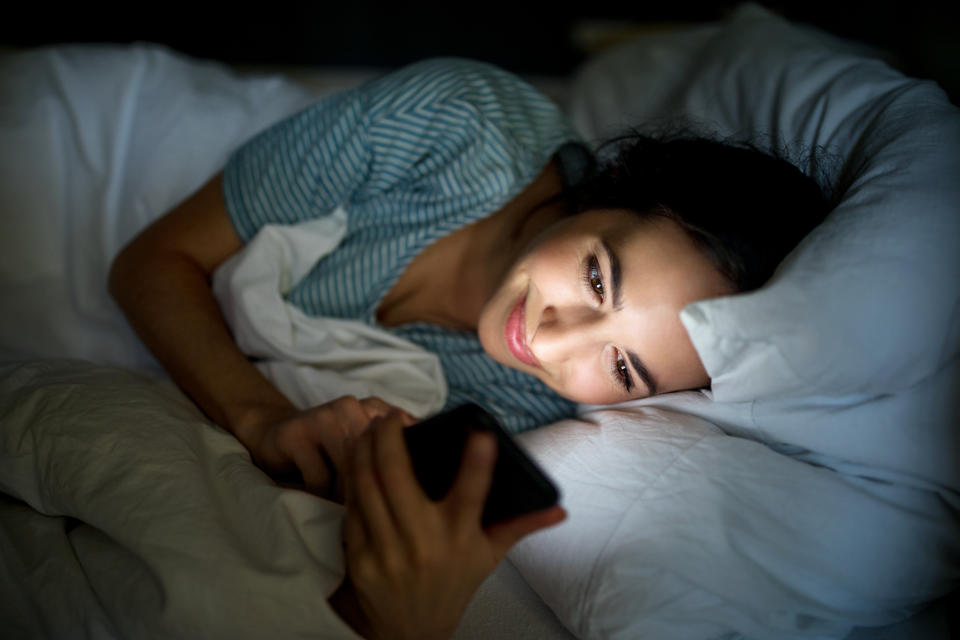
223;58;583;432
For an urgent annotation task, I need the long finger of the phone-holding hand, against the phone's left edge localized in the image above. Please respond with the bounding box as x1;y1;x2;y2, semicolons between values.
371;411;427;539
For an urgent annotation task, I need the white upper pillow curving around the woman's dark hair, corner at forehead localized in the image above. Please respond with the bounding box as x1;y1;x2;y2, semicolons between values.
570;5;960;402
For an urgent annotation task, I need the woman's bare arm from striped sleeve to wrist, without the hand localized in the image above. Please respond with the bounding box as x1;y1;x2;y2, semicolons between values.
110;174;284;444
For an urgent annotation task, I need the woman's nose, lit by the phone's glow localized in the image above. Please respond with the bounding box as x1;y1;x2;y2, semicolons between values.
529;306;605;364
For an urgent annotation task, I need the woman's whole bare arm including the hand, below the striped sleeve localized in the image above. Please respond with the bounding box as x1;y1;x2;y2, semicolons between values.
109;174;387;493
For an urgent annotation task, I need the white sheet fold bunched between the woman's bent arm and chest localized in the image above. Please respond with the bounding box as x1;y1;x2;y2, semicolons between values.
213;207;447;416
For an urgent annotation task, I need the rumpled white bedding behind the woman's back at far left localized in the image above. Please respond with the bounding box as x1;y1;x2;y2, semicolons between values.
0;44;314;368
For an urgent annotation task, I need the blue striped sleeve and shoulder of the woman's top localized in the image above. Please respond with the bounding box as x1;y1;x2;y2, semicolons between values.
223;58;576;242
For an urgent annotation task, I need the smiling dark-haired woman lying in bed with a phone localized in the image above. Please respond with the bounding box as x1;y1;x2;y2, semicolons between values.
110;60;826;637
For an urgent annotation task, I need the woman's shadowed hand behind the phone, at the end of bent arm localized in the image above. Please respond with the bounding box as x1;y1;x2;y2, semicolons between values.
244;396;414;497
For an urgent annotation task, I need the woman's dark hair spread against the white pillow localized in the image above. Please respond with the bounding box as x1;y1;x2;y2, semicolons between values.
569;132;830;291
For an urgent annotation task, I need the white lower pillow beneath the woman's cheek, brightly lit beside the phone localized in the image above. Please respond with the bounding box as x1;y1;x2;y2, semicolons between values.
509;404;960;640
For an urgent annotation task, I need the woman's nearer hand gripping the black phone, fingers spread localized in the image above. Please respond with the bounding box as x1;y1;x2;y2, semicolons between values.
330;414;566;638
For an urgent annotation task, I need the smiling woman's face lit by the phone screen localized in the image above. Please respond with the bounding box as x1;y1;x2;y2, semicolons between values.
478;210;733;404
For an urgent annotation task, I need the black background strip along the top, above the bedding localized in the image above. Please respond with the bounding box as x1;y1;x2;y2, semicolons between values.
0;0;960;104
